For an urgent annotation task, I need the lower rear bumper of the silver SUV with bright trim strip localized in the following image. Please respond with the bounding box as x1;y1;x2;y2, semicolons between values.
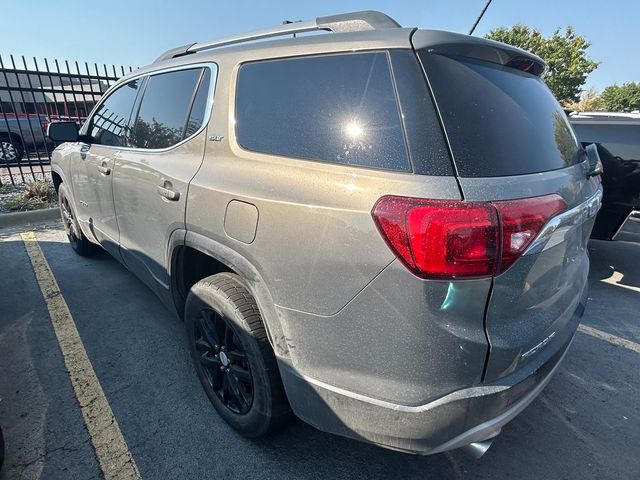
281;326;573;455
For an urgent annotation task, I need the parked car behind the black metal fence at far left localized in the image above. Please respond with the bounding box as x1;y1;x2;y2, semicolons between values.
0;113;53;167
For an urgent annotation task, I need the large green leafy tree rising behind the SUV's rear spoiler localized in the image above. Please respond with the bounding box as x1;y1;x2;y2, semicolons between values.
486;24;598;102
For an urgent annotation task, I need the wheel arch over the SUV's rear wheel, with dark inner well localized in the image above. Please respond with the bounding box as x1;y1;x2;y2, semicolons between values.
169;232;289;357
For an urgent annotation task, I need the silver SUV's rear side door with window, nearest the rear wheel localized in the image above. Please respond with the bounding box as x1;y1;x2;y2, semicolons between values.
113;65;216;295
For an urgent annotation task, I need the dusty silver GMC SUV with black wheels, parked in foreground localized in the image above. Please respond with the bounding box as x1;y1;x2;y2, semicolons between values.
49;12;601;454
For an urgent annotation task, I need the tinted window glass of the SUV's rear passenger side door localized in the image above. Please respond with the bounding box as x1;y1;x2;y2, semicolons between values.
131;68;202;148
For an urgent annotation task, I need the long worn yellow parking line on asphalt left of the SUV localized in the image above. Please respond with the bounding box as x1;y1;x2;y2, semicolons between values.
21;232;141;480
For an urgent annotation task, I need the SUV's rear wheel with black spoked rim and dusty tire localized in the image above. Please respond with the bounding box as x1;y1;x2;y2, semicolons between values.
185;273;289;438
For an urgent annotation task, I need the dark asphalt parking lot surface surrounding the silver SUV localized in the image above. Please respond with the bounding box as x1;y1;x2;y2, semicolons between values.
0;225;640;479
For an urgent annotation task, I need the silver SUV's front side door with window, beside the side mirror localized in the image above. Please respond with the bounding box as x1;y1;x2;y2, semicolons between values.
72;79;142;257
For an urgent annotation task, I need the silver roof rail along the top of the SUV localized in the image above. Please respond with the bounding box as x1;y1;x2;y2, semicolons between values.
156;10;400;62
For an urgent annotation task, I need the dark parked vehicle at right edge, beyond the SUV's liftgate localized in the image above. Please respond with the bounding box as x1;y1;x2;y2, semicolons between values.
569;112;640;240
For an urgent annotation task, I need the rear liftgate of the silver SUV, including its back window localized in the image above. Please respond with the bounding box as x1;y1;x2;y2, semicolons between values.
414;34;601;381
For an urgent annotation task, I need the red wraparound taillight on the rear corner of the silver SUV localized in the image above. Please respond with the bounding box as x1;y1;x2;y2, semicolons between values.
371;195;566;280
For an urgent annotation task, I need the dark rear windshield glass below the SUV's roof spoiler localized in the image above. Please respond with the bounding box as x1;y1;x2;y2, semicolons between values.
419;51;582;177
